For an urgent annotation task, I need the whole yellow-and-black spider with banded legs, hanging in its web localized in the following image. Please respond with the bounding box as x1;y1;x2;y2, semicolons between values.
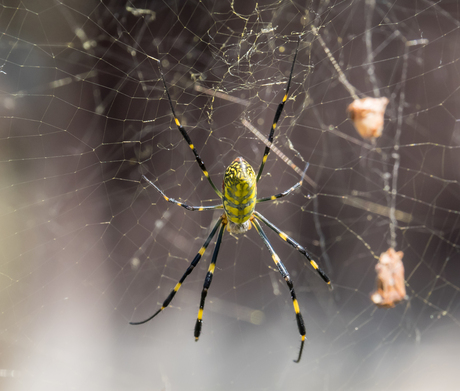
130;37;330;362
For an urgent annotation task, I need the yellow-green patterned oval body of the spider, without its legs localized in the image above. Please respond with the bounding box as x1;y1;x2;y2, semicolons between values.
222;157;257;233
